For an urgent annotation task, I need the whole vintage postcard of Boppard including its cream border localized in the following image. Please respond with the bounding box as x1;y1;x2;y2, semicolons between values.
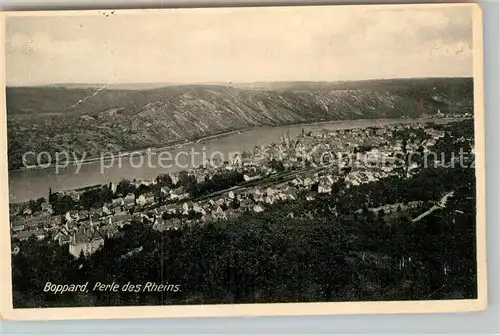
0;4;486;319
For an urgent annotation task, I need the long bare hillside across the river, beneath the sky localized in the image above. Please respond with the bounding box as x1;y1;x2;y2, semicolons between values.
7;78;473;168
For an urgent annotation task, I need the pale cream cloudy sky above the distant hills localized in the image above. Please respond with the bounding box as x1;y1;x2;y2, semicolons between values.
6;5;473;86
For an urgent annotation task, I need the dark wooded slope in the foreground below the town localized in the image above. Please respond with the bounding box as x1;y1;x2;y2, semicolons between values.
12;128;477;307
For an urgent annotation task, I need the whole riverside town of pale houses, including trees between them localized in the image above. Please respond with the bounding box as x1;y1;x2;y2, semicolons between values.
11;124;465;257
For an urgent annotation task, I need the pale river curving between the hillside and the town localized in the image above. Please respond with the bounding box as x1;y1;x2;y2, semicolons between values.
9;119;456;203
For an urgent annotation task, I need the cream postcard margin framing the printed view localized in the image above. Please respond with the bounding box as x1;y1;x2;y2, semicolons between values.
0;3;487;321
